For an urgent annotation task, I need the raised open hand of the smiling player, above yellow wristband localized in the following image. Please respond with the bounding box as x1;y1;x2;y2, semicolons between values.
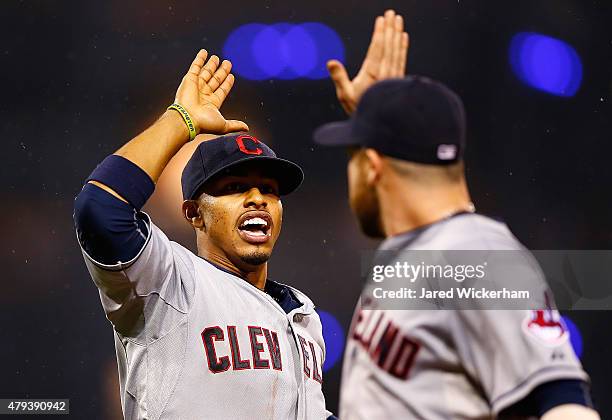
175;50;249;134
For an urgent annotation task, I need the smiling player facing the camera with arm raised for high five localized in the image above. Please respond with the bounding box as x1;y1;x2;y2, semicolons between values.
74;50;329;420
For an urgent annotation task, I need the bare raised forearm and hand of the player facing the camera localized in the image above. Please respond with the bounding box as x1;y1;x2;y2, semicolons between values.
90;50;249;201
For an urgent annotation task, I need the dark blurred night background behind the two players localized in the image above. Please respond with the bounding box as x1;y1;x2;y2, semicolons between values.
0;0;612;419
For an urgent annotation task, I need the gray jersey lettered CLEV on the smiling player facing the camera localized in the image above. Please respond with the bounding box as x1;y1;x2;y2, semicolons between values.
83;216;327;420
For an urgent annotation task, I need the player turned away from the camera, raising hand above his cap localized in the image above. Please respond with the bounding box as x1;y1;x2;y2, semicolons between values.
315;11;599;420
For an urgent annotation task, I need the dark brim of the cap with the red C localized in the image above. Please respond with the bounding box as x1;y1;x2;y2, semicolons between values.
194;156;304;199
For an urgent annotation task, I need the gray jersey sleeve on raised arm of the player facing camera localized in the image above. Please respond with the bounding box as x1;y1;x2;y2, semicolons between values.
81;213;194;337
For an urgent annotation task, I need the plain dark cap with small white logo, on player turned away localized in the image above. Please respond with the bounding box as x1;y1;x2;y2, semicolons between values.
314;76;465;165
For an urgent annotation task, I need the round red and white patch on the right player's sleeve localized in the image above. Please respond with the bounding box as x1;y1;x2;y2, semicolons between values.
523;309;569;347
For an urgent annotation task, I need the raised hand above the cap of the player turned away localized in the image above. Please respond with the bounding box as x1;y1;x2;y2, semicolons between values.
327;10;409;114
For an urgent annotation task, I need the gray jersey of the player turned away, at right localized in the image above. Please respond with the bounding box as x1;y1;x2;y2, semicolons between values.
340;214;588;420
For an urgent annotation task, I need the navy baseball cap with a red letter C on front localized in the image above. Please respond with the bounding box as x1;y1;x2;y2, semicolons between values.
181;133;304;200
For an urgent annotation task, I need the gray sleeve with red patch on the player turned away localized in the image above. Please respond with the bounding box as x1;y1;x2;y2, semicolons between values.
450;310;588;414
